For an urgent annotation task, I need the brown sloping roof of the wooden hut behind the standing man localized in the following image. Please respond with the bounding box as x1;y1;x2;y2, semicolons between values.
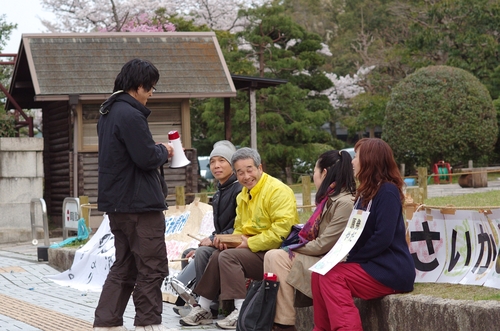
6;32;236;108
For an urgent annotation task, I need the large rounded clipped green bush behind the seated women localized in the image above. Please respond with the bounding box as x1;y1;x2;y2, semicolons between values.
382;66;498;169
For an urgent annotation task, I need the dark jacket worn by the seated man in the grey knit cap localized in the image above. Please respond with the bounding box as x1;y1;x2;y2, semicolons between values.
210;174;241;241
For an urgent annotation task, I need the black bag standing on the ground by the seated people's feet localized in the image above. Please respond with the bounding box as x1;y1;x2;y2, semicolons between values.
236;279;280;331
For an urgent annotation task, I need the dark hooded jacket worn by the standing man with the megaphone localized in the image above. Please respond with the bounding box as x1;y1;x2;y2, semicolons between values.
97;93;168;213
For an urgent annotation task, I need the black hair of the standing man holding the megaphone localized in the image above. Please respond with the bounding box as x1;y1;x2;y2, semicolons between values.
113;59;160;93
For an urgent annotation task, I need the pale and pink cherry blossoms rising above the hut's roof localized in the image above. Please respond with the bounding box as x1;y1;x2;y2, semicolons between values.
41;0;270;32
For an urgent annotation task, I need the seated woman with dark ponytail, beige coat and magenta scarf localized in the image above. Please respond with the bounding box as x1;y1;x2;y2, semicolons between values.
264;150;356;331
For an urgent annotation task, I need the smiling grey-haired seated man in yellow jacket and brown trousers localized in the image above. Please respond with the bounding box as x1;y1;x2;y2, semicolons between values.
180;147;299;329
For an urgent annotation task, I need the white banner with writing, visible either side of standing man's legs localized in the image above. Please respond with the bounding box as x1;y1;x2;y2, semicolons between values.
46;202;214;291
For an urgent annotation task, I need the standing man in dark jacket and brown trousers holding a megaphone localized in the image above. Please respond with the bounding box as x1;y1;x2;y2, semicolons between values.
94;59;173;331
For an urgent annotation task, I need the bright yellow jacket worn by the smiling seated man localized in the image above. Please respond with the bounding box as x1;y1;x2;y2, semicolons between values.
233;173;299;252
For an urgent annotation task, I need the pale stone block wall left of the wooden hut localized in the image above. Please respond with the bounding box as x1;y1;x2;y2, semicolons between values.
0;138;44;243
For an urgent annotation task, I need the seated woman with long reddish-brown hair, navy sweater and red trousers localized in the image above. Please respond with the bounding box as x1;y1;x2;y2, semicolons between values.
311;138;415;331
